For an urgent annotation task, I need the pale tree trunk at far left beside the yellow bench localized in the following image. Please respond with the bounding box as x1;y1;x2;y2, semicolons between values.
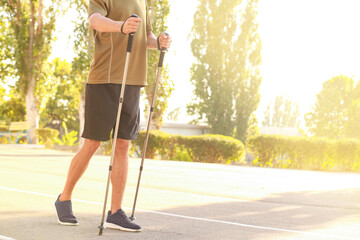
25;77;39;144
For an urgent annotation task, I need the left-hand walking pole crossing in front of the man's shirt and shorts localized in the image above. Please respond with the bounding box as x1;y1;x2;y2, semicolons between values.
98;14;138;236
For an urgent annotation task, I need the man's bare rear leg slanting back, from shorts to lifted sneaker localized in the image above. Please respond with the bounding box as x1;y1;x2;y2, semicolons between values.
59;139;100;201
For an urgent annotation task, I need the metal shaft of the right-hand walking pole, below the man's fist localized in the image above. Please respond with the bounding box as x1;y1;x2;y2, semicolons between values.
130;62;163;221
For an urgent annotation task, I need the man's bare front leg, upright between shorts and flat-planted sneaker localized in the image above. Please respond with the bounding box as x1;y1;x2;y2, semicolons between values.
111;139;130;214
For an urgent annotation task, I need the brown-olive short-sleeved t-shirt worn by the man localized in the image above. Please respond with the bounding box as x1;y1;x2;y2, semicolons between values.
87;0;152;86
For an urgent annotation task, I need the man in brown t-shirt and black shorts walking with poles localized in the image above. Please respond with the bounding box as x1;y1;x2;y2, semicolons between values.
55;0;171;231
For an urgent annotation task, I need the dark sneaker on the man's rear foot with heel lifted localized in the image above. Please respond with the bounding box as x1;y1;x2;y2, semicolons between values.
54;194;79;226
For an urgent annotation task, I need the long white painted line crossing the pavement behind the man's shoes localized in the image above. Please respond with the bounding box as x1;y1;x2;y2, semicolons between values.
0;186;358;240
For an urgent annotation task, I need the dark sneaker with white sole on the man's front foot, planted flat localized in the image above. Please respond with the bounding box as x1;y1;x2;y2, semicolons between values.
104;209;141;232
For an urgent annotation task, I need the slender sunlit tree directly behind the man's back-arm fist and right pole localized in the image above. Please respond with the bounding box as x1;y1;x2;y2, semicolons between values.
144;0;174;129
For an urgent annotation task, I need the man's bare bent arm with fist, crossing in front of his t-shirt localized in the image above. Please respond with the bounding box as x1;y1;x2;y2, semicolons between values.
89;13;141;34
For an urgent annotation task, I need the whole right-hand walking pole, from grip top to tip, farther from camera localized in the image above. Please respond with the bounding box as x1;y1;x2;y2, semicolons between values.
130;32;169;221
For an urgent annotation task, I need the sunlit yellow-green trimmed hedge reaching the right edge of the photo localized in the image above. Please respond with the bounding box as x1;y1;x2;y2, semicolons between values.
247;135;360;171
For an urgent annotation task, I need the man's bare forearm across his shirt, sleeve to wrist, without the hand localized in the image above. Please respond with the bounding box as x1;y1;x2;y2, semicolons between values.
89;13;124;32
